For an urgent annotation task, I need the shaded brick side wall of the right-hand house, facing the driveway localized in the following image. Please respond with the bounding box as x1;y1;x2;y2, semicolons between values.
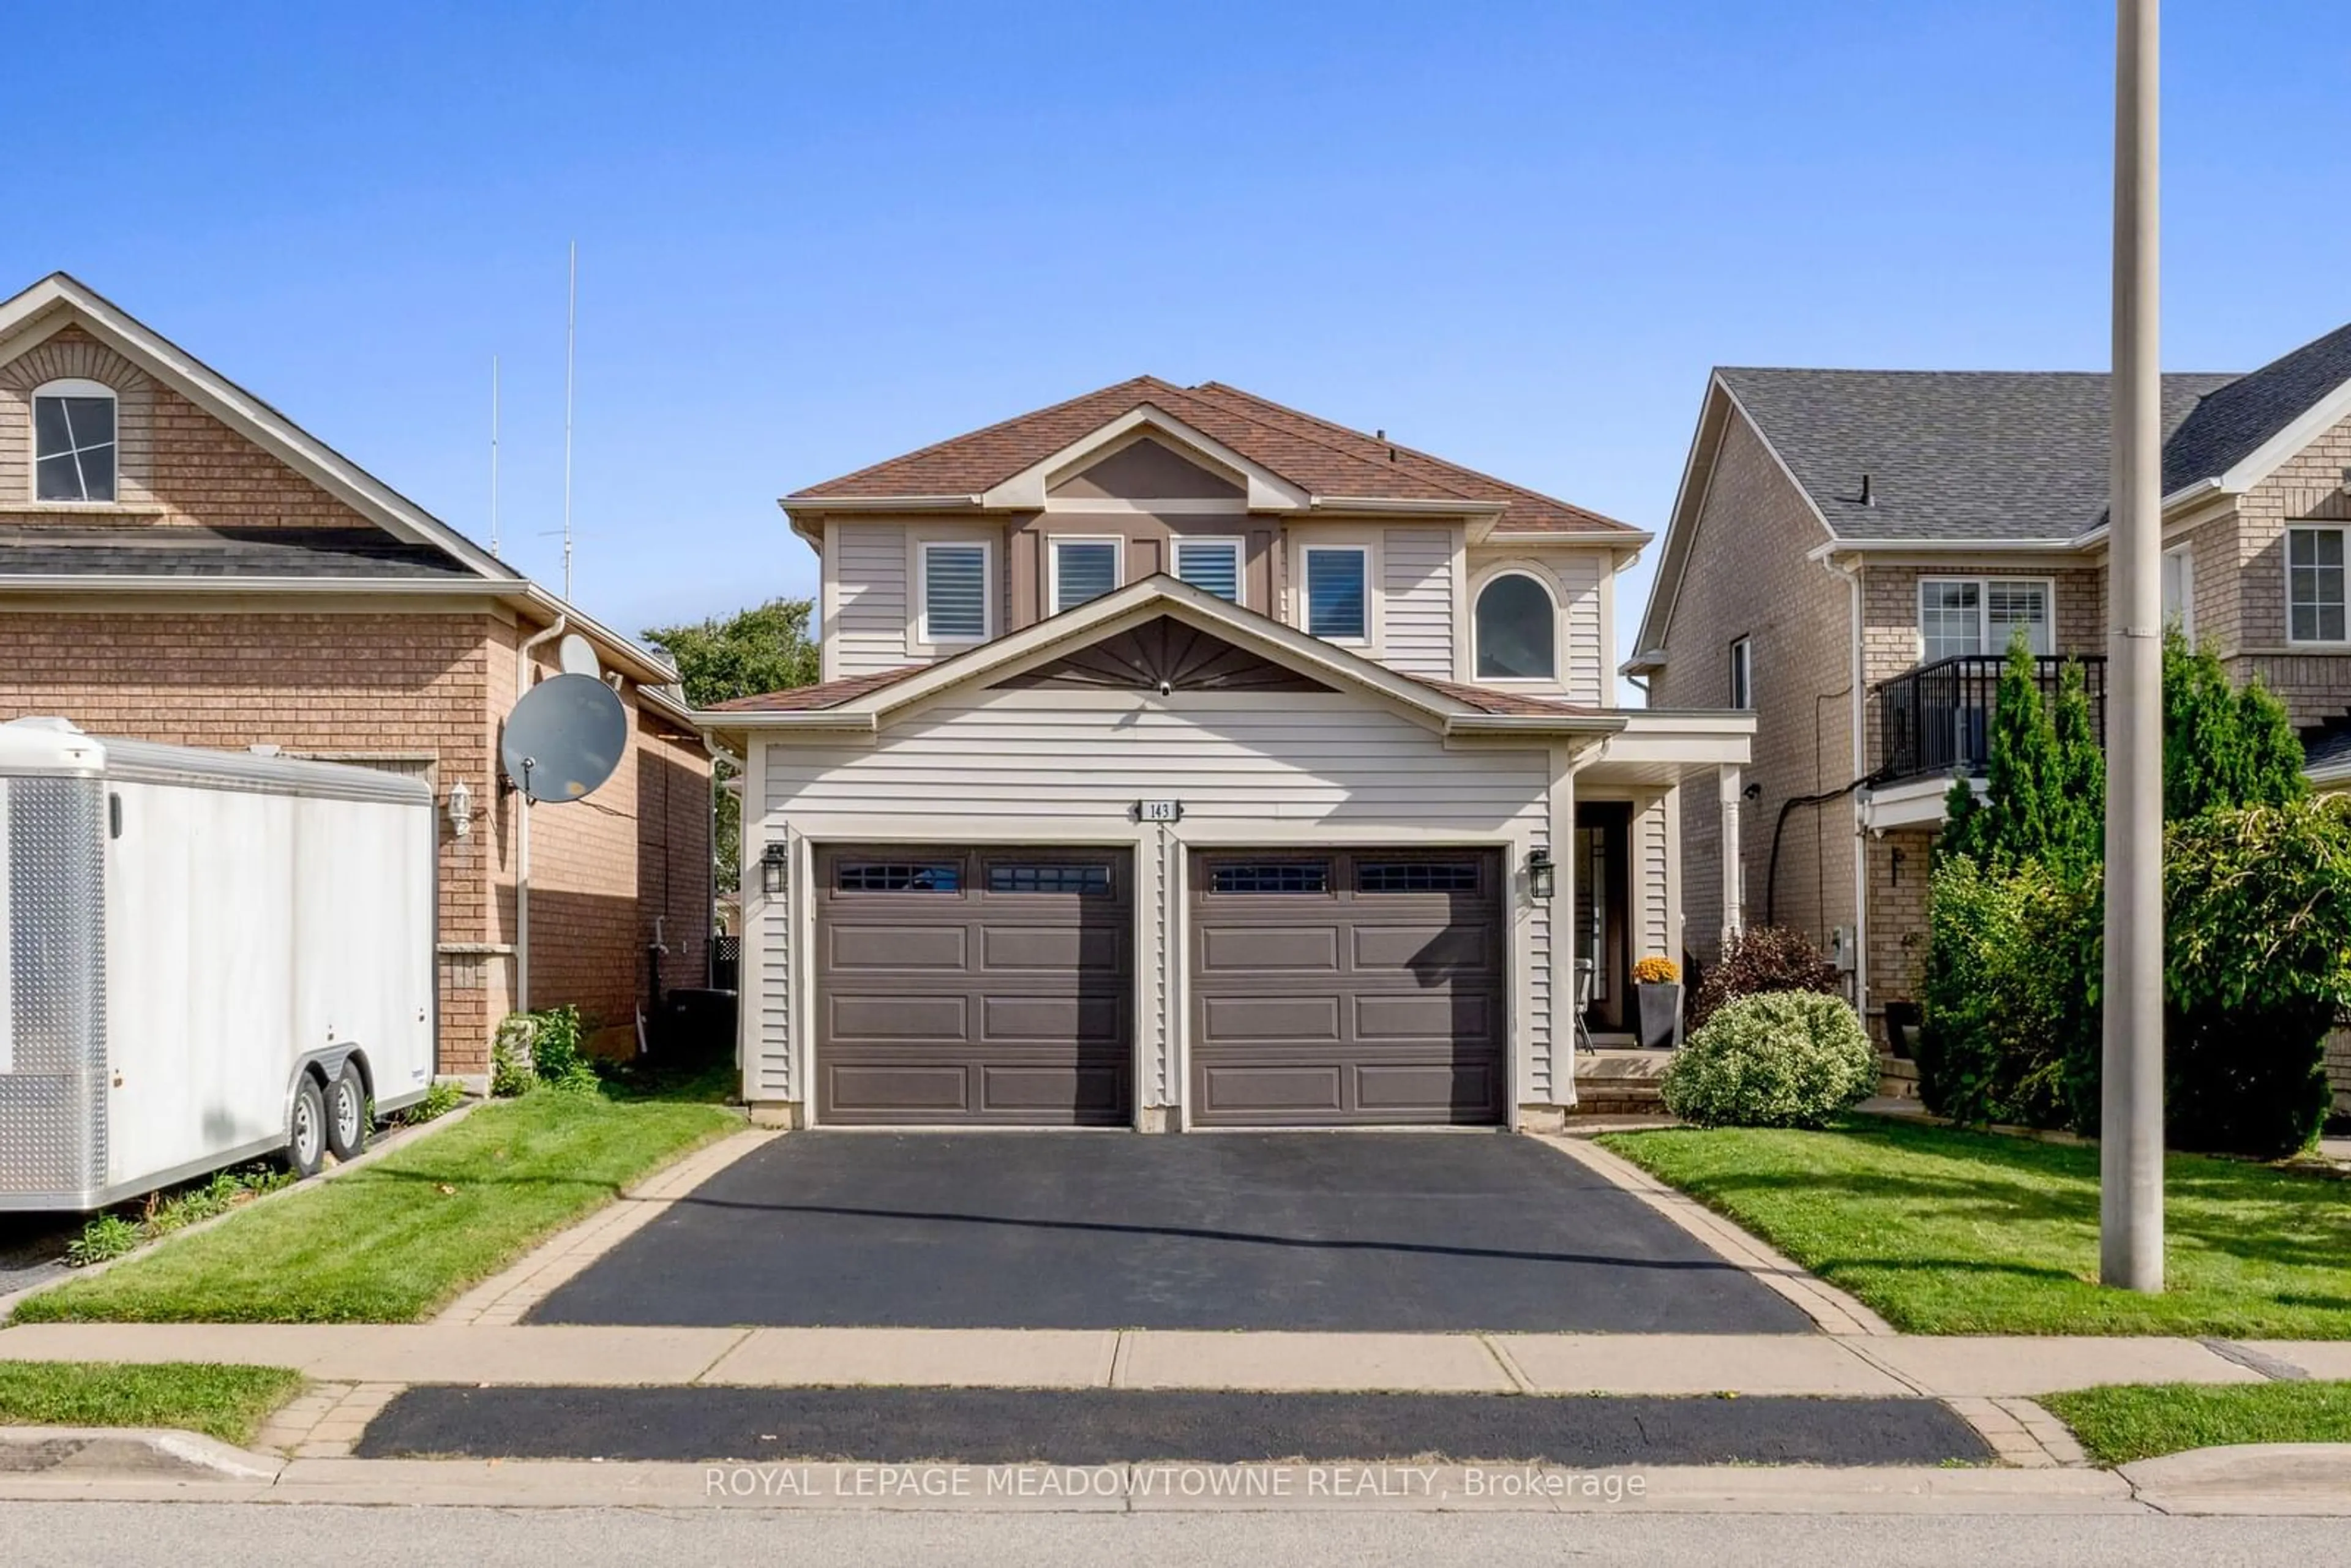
1651;414;1853;964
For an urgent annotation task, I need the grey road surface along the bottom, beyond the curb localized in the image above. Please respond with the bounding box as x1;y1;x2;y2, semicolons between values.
0;1502;2344;1568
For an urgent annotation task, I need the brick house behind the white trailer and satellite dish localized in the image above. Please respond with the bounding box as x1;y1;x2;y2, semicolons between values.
0;272;710;1075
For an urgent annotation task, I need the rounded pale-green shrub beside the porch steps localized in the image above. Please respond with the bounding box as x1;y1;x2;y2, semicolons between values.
1662;992;1878;1126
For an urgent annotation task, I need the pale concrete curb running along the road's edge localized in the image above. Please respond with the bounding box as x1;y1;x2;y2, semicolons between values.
0;1431;2351;1517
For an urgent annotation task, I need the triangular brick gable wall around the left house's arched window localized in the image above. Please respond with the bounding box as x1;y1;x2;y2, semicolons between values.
0;327;374;529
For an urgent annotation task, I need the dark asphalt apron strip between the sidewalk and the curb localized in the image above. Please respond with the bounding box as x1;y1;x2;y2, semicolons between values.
358;1387;1991;1467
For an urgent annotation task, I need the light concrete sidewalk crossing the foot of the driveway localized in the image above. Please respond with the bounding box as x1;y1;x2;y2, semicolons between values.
0;1324;2322;1399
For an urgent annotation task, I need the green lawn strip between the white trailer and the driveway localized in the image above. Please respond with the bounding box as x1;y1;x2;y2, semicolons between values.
17;1089;743;1324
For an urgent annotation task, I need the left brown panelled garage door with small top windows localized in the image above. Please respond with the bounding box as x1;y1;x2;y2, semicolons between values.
816;844;1136;1126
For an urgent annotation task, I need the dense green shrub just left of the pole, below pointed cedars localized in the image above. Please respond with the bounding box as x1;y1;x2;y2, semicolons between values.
1918;856;2104;1126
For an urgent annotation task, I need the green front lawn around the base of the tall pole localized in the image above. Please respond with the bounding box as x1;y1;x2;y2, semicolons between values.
1601;1117;2351;1340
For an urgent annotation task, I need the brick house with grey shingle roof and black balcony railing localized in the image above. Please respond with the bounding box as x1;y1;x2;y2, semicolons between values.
1624;327;2351;1090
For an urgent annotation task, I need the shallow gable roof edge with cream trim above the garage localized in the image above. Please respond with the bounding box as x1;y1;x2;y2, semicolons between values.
696;574;1624;733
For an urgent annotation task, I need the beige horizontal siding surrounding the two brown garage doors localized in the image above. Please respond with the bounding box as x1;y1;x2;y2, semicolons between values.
757;691;1551;1105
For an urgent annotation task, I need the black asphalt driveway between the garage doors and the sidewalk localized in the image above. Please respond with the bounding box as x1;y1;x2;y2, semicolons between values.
529;1131;1810;1333
